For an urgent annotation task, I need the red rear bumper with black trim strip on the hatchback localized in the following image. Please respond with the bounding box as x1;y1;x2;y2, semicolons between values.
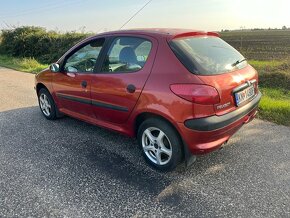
178;92;262;154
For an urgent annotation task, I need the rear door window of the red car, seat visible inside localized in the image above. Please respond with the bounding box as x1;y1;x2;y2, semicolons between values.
101;37;152;72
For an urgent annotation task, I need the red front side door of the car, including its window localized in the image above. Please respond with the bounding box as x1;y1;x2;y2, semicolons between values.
52;38;105;120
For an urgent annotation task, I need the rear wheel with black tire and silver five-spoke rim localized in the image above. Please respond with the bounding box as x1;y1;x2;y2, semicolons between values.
137;118;183;171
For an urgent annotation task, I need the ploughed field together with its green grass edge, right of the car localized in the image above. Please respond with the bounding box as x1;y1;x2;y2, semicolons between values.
221;30;290;126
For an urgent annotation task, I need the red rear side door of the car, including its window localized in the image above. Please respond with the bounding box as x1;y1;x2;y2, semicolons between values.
91;36;157;124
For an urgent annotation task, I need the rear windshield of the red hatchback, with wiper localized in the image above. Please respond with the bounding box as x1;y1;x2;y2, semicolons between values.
169;36;247;75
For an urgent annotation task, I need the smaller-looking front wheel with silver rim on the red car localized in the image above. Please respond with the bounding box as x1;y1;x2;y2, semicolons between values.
38;88;57;120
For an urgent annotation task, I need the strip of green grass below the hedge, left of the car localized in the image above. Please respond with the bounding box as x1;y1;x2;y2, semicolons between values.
0;55;48;73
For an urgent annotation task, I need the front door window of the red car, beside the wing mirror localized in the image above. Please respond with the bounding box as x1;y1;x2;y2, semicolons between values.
64;38;105;72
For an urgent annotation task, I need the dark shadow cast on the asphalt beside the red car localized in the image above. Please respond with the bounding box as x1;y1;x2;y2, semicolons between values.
1;107;174;193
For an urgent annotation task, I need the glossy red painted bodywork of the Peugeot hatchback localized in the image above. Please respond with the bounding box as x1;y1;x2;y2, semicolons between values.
36;29;258;154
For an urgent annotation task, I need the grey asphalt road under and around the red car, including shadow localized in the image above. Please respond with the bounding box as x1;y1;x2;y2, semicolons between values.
0;68;290;217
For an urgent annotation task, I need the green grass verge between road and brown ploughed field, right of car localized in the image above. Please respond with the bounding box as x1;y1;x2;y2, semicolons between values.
249;60;290;126
